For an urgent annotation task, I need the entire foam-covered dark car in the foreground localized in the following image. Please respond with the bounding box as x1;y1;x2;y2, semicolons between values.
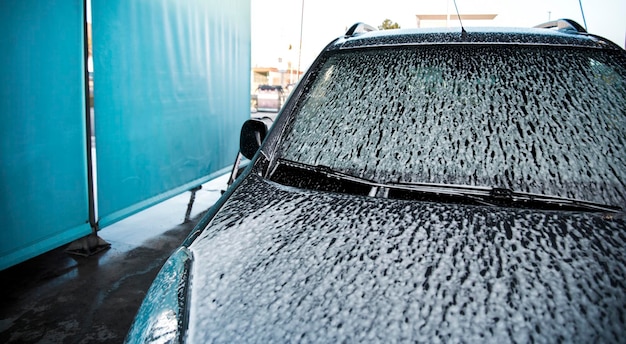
127;20;626;343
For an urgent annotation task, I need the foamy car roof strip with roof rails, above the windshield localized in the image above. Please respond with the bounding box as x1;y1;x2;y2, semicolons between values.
326;19;623;51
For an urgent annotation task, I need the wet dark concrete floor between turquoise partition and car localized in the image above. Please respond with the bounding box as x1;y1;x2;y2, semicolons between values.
0;175;228;343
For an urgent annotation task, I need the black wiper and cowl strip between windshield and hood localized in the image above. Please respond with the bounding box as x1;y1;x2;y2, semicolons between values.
271;159;623;213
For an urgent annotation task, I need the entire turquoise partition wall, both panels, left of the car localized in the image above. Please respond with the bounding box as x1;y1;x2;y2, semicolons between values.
0;0;250;270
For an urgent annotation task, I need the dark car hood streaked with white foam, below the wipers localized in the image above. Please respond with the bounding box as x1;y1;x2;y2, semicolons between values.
187;175;626;343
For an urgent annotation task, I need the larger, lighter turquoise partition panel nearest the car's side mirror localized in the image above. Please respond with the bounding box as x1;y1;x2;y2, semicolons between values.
92;0;250;227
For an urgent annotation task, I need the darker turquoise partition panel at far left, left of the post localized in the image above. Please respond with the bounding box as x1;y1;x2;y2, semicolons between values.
0;0;91;270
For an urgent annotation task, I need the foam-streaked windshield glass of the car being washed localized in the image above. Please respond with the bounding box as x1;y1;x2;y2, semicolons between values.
279;46;626;206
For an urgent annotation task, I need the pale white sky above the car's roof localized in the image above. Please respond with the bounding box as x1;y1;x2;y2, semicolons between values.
251;0;626;70
